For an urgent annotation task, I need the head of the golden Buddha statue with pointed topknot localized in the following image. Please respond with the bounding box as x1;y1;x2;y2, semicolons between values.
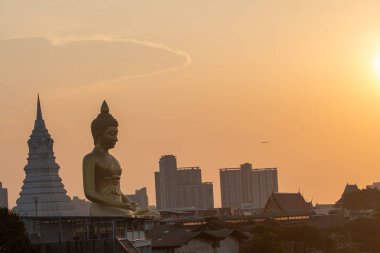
91;101;119;150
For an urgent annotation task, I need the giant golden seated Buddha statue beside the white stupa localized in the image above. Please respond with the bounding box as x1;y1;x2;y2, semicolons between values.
83;101;160;218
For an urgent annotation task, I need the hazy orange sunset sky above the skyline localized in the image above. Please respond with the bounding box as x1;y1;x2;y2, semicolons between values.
0;0;380;207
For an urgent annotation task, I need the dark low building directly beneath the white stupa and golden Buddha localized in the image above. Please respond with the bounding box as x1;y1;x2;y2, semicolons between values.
22;216;153;253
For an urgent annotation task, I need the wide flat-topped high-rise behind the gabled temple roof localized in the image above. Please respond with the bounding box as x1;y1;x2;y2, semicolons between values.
219;163;278;208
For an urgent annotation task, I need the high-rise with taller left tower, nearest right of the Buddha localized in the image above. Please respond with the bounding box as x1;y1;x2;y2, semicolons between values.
155;155;214;209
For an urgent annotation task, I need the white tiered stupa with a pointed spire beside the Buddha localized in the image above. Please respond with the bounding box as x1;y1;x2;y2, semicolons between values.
14;98;73;216
